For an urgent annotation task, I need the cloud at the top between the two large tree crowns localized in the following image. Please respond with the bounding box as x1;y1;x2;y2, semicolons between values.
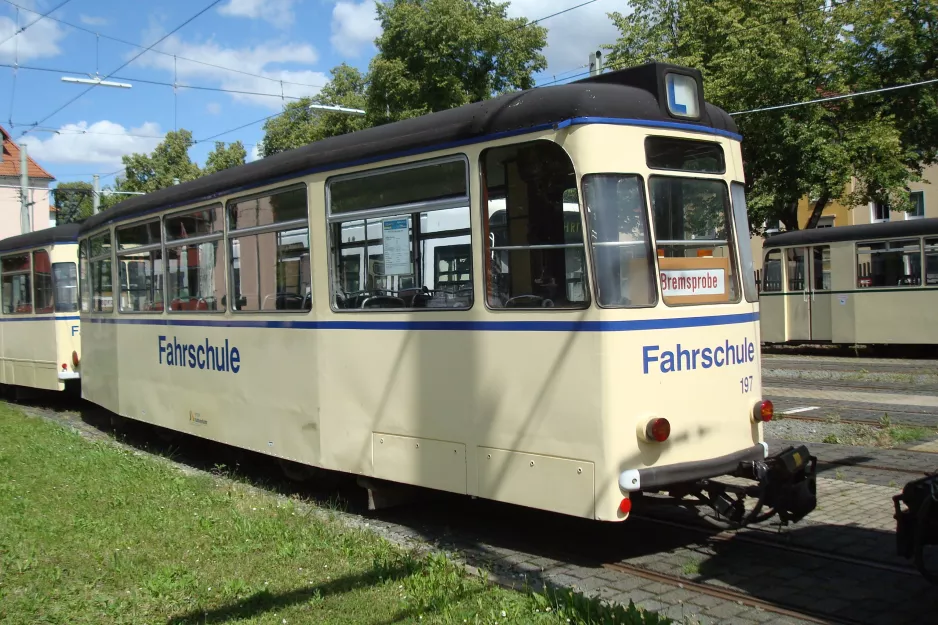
508;0;630;78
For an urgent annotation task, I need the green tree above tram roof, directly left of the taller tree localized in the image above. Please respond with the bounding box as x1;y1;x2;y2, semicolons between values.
261;63;371;157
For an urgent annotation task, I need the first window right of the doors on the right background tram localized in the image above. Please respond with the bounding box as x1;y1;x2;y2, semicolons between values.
857;239;922;288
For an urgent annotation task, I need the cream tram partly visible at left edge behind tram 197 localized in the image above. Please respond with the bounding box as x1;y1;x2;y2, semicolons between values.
0;224;81;391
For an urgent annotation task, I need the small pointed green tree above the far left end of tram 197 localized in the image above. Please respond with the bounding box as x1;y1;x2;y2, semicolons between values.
116;130;200;193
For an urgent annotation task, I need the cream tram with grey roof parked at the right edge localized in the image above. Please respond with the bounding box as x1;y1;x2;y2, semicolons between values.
760;218;938;345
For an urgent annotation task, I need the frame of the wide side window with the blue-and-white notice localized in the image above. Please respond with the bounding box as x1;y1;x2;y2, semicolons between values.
328;152;476;314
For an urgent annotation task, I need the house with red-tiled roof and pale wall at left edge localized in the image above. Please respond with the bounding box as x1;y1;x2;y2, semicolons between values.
0;126;55;239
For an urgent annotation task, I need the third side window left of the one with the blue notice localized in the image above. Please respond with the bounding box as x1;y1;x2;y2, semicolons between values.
116;219;163;312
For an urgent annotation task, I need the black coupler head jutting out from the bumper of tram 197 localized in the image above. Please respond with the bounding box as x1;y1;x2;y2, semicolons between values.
734;445;817;525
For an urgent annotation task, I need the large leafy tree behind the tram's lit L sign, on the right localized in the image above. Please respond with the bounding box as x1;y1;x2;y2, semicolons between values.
608;0;938;229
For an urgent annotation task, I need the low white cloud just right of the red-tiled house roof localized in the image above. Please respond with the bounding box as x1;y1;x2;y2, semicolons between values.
22;120;163;169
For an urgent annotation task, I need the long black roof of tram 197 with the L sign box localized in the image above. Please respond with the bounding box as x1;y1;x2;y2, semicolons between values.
81;63;740;232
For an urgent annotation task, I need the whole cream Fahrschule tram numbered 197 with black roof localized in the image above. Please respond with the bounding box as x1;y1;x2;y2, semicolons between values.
81;64;814;522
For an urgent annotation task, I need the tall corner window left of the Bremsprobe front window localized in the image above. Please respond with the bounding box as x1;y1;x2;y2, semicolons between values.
583;174;658;308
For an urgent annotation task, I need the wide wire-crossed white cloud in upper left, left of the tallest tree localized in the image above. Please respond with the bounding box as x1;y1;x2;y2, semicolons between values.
134;32;329;110
